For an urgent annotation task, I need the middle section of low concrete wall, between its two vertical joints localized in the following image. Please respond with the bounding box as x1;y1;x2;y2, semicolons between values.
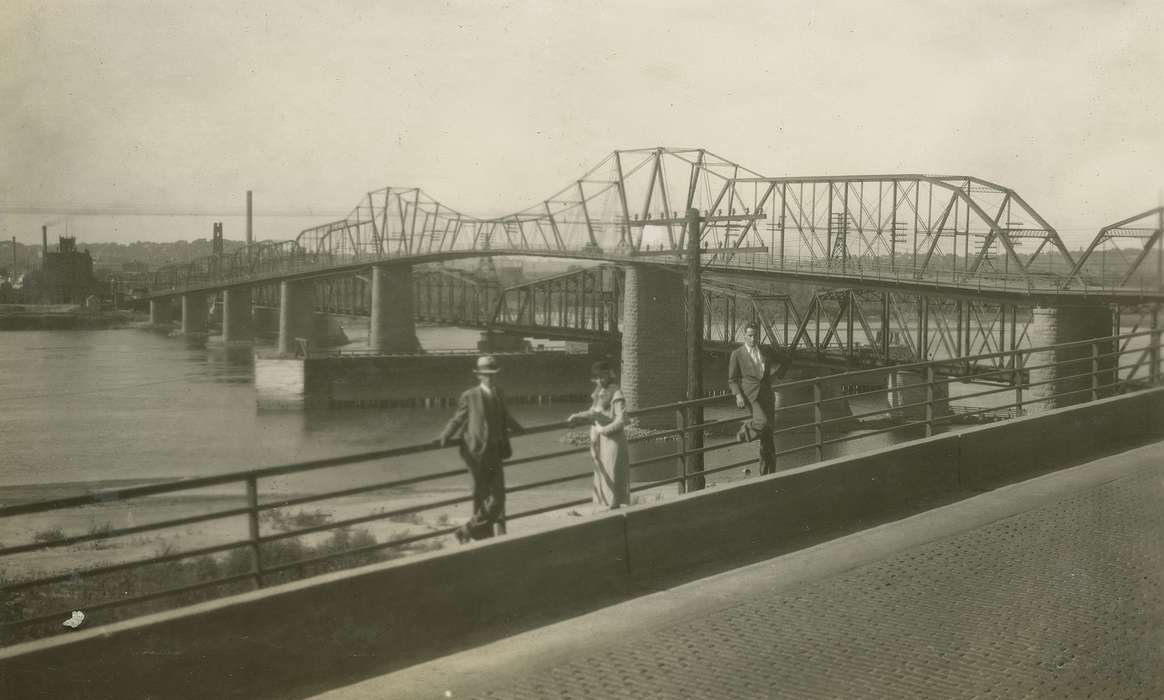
626;434;958;580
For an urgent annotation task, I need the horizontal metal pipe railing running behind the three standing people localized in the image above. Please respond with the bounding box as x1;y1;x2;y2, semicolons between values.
0;330;1161;631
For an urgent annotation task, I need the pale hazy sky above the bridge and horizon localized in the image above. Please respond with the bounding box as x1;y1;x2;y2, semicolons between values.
0;0;1164;245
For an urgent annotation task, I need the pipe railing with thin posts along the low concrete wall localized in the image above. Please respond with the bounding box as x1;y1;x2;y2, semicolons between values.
0;328;1164;643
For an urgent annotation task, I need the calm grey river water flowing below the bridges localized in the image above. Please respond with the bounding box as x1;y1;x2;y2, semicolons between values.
0;327;945;500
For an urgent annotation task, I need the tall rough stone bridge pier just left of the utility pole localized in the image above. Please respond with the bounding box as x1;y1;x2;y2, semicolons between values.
620;266;687;427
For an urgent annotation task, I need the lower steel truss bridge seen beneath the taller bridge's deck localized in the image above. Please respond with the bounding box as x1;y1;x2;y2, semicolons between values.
255;264;1158;374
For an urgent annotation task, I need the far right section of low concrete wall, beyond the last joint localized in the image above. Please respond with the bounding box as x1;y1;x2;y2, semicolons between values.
959;388;1164;490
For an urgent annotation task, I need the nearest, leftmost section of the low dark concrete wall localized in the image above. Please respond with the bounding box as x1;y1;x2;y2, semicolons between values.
0;515;627;700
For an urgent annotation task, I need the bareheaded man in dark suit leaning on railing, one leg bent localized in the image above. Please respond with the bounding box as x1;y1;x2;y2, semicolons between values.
728;321;783;474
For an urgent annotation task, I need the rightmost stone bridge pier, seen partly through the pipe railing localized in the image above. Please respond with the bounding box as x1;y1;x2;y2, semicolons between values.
1024;304;1117;413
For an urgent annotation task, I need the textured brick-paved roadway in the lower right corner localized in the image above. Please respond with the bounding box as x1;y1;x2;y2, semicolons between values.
465;465;1164;698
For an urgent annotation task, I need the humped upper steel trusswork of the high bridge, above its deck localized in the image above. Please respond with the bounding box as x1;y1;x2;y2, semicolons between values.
151;148;1164;300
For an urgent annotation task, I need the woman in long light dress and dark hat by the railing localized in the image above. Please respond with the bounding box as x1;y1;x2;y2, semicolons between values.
569;362;631;510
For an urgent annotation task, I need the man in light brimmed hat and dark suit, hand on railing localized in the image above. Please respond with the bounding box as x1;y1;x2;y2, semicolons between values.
438;355;523;543
